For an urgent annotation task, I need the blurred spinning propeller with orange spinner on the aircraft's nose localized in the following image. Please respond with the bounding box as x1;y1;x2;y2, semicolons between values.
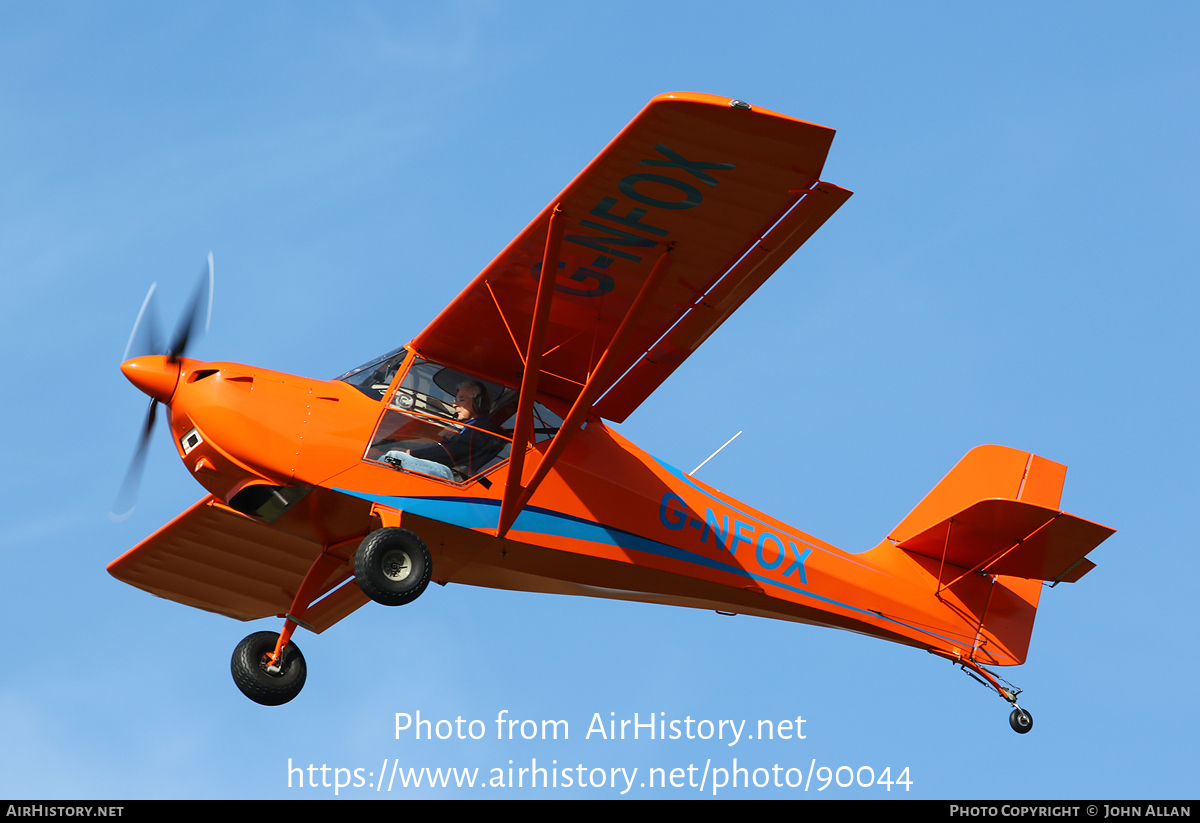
108;252;214;522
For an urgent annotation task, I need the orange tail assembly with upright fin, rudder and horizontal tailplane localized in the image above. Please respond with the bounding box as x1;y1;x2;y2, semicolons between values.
888;446;1114;662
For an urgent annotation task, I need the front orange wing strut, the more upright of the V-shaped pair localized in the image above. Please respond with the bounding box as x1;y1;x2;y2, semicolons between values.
499;204;566;536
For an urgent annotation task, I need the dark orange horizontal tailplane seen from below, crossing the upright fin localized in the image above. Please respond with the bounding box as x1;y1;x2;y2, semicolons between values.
896;499;1114;582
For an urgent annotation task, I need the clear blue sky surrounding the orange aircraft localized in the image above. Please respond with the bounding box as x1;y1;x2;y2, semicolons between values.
0;2;1200;799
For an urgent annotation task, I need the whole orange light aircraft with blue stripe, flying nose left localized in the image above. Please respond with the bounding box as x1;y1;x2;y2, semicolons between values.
108;94;1112;733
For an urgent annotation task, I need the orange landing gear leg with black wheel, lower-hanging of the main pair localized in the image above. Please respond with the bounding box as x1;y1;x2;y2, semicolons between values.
229;552;346;705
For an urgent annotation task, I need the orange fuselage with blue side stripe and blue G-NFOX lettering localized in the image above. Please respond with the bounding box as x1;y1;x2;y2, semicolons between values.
124;358;1040;666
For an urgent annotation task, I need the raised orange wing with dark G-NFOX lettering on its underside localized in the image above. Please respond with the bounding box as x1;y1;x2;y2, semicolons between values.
413;94;851;422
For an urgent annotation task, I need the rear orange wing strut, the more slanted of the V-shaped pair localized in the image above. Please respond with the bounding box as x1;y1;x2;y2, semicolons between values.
496;239;674;537
